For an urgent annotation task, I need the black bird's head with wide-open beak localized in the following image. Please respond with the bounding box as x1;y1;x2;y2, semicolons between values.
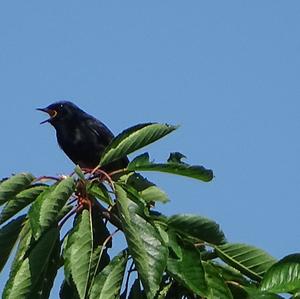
37;101;82;126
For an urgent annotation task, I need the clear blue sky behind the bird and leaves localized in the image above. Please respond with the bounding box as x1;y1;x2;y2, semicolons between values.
0;0;300;298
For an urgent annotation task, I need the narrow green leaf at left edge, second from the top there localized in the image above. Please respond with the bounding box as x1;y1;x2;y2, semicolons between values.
0;186;48;224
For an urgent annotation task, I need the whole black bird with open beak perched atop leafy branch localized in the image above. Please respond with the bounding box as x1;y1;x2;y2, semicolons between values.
37;101;128;171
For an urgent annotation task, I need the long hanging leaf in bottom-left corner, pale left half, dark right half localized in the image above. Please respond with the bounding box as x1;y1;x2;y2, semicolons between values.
3;228;59;299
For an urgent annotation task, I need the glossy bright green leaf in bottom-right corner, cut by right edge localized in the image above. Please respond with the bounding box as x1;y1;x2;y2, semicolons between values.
260;253;300;293
